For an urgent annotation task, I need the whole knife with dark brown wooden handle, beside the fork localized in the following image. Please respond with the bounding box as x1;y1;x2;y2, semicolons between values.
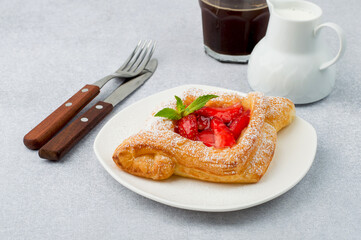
39;59;158;161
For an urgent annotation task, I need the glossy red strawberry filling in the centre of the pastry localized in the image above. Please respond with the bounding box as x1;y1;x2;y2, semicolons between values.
174;104;250;148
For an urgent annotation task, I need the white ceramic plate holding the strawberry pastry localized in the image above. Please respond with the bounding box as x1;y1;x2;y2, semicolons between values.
94;85;317;212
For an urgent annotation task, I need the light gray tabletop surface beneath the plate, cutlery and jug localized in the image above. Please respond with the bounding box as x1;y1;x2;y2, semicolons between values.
0;0;361;239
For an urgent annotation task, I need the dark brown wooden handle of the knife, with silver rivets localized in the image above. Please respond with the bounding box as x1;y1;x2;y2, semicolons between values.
39;101;113;161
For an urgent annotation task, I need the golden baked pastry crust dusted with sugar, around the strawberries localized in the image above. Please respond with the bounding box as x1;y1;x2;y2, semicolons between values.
113;89;295;183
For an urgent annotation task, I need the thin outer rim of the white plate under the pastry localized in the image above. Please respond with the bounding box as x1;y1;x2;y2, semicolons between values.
93;84;318;212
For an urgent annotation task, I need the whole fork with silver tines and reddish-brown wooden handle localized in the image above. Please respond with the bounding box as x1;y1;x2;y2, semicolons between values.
24;40;155;150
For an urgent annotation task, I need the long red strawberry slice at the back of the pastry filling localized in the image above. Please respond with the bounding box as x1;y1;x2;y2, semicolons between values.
195;103;243;123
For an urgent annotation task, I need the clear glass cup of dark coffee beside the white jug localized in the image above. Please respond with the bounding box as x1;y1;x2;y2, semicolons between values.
198;0;269;63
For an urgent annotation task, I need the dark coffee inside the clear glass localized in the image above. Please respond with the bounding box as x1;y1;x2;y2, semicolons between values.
199;0;269;55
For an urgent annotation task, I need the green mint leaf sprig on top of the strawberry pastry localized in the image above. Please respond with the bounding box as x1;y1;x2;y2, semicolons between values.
154;95;218;120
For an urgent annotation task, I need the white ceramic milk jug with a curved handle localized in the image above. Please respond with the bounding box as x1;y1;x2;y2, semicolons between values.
248;0;345;104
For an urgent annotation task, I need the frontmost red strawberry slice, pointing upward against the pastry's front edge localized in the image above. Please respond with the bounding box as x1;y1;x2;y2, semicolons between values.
211;117;236;148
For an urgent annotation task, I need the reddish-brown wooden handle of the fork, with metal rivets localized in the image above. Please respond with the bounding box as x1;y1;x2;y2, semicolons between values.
24;85;100;149
